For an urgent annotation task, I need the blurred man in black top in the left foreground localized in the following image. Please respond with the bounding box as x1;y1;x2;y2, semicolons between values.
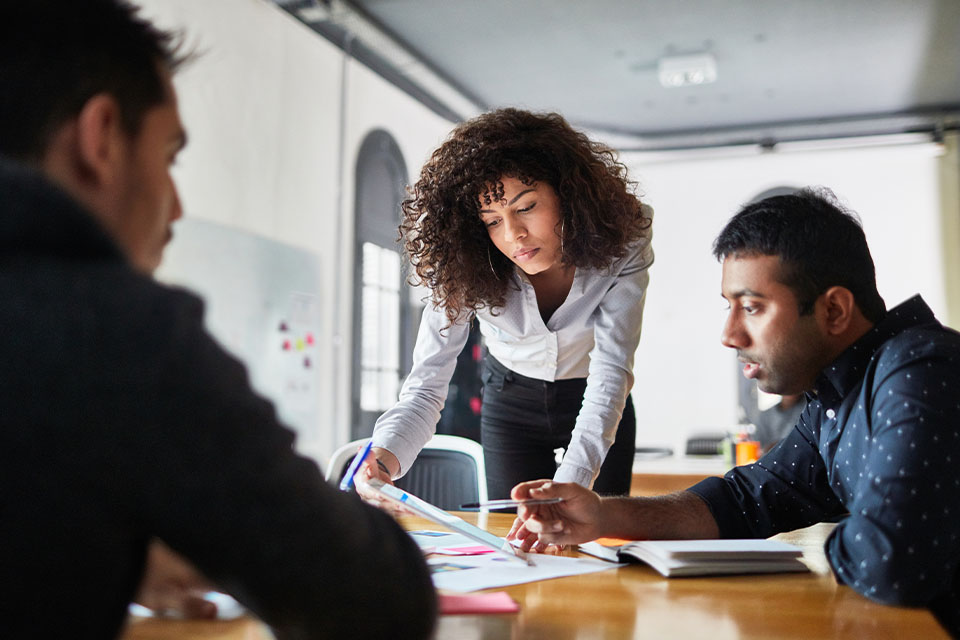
0;0;436;639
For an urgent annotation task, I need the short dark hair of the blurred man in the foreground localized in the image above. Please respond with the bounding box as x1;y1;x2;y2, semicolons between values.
0;0;188;162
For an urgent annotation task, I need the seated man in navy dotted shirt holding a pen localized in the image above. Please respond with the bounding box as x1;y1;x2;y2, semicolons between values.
513;186;960;634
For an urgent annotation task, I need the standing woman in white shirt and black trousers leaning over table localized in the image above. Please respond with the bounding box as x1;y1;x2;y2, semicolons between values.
366;109;653;498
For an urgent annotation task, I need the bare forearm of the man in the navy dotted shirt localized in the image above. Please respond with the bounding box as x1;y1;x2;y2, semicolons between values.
600;491;720;540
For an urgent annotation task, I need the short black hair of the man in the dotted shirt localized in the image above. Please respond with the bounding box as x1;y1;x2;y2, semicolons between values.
713;188;886;323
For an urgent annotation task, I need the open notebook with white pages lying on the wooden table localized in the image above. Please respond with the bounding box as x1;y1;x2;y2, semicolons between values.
580;539;810;577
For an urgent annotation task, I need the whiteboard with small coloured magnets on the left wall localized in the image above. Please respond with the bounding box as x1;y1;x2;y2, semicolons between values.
157;219;327;449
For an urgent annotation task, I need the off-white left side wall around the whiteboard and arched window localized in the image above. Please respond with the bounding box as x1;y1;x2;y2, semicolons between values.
137;0;451;462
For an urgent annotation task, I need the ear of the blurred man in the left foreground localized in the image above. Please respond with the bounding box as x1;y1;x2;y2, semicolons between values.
75;93;126;188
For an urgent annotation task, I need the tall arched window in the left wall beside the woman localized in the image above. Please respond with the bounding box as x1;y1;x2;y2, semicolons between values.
350;130;416;439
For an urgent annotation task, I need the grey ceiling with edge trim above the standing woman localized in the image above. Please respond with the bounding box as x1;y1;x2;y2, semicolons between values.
276;0;960;148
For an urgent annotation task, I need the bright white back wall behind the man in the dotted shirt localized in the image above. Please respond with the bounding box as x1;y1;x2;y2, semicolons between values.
624;136;960;447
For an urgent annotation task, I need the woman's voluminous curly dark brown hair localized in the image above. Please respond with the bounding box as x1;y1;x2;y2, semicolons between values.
400;108;651;323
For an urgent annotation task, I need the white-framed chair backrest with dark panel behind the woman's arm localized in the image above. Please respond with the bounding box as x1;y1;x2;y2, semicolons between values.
327;435;487;511
